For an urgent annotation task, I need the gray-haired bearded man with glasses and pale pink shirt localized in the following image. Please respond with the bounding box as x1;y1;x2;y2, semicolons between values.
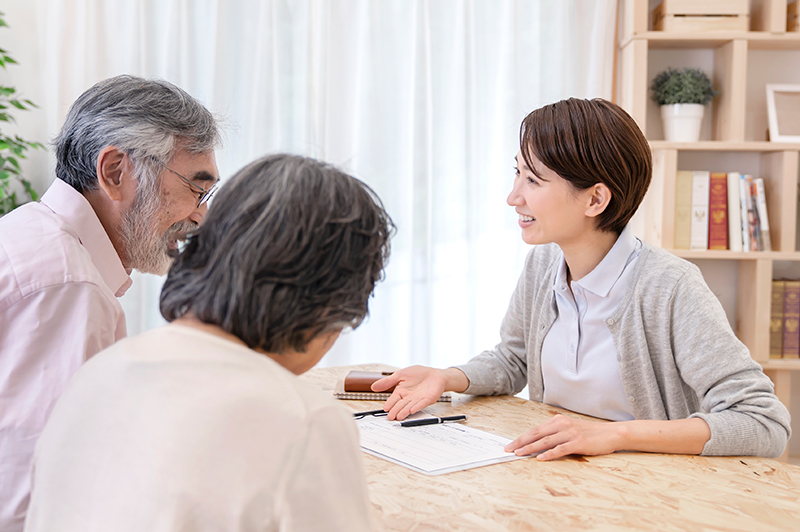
0;72;219;532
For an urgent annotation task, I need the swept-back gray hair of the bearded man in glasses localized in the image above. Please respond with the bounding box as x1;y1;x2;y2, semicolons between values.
53;75;220;193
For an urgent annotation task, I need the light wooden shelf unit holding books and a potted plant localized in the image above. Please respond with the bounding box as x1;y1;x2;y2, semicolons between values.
617;0;800;460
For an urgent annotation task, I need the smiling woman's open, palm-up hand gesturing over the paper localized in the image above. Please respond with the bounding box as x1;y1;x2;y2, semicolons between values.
372;366;469;420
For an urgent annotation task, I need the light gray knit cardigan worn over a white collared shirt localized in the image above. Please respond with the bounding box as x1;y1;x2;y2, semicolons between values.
458;243;791;457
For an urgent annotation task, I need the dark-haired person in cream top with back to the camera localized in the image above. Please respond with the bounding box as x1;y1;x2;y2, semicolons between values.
25;155;393;532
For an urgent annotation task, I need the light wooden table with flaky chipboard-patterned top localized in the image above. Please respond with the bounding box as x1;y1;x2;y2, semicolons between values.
303;364;800;532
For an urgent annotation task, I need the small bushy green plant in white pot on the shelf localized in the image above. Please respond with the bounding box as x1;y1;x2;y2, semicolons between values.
650;68;717;142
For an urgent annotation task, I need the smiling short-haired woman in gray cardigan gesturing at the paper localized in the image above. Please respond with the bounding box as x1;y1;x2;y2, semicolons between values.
373;99;790;460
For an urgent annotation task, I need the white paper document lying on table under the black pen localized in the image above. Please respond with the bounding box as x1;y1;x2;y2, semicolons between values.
356;416;527;475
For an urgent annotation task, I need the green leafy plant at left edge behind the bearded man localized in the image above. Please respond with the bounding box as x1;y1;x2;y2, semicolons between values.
0;12;44;216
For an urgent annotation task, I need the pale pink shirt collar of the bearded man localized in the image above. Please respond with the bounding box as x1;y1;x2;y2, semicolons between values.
42;178;133;297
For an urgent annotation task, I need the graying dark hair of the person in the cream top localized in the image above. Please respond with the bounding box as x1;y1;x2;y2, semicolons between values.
161;155;394;353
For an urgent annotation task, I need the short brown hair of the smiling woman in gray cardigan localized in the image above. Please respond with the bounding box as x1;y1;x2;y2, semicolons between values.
519;98;653;234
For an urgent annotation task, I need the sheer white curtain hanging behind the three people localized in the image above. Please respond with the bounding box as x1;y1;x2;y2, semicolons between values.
20;0;617;366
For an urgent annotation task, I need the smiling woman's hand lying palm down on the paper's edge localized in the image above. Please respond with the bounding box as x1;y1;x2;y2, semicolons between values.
505;414;623;460
